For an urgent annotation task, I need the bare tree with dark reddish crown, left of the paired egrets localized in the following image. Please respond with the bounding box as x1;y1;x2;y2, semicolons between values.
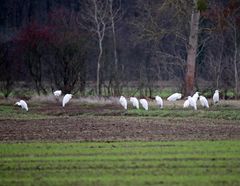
16;22;52;95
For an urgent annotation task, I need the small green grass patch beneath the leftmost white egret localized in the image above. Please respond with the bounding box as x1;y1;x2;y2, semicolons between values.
0;105;49;120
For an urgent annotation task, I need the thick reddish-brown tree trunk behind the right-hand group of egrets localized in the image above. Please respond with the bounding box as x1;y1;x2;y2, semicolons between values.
184;0;200;96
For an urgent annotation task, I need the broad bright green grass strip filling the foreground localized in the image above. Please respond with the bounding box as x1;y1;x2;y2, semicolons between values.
0;141;240;186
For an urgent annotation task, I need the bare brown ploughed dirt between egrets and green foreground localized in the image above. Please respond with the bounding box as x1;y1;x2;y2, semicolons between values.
0;104;240;141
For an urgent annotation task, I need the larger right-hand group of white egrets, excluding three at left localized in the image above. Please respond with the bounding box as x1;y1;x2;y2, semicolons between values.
119;90;219;110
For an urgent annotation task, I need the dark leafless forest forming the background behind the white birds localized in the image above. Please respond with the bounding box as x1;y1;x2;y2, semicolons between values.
0;0;240;98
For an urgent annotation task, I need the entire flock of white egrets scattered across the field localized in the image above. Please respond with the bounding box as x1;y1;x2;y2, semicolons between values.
15;90;219;111
